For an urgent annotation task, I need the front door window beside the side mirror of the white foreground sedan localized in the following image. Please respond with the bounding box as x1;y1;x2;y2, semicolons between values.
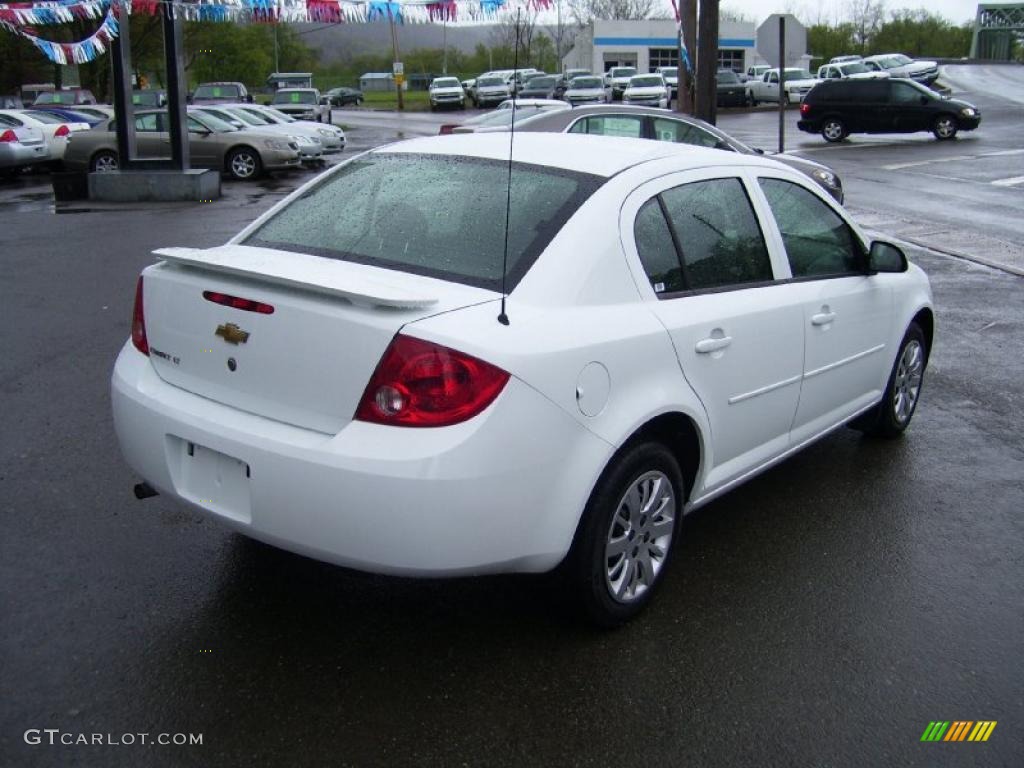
760;178;862;278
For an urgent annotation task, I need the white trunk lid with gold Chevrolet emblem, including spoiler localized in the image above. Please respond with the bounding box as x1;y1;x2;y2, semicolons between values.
143;245;496;434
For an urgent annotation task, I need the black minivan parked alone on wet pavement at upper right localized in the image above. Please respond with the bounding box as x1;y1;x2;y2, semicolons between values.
797;78;981;141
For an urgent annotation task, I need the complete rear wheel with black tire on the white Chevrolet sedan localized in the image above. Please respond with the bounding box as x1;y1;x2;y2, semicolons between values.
566;442;686;628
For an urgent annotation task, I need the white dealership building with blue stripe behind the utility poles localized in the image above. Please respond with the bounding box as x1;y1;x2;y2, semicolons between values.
562;19;764;73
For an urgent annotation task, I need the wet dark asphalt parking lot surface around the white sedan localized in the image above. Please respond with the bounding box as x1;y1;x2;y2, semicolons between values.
0;67;1024;766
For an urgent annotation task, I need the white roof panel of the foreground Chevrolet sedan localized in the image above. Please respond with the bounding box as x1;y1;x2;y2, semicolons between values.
372;132;770;177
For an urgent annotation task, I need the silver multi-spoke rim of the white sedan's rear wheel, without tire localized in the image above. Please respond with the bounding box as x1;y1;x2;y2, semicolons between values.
604;470;676;603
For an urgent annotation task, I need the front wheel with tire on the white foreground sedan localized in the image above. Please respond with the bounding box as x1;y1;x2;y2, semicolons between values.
852;323;928;438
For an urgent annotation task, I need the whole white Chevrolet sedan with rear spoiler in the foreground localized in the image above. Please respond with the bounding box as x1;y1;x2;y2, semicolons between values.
112;133;933;625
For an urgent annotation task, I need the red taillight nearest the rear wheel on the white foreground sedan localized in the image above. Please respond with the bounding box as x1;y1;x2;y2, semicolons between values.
355;335;509;427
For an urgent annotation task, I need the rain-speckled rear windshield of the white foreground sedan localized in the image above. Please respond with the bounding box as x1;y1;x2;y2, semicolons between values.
245;153;603;291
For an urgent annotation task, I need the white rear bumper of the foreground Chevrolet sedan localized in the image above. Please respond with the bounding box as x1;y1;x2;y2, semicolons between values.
112;342;612;575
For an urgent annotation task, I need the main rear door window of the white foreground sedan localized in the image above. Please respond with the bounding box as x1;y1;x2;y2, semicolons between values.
662;178;772;290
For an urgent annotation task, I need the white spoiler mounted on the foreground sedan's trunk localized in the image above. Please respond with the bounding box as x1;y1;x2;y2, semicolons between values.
153;245;438;309
